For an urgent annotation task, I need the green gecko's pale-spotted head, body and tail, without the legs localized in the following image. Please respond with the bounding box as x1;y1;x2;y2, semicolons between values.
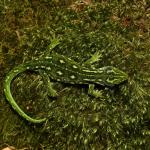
4;53;128;123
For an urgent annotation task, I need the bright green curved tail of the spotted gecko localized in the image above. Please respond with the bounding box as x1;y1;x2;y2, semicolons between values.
4;64;46;123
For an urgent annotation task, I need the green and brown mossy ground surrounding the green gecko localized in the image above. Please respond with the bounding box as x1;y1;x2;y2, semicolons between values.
0;0;150;150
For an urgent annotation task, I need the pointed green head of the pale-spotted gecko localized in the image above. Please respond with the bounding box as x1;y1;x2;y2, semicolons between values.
105;66;128;86
